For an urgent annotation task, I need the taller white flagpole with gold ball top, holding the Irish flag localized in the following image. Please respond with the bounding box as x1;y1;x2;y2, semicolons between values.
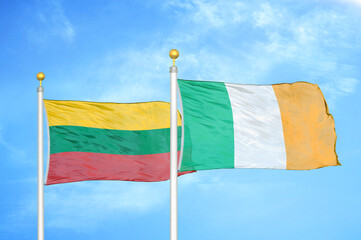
169;49;179;240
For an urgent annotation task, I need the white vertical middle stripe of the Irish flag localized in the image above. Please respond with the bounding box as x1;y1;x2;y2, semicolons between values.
225;83;287;169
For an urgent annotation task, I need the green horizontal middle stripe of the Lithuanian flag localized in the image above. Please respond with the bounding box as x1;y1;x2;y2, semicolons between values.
50;126;182;155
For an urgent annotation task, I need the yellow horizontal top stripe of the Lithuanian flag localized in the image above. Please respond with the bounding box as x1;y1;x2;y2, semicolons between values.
44;100;182;130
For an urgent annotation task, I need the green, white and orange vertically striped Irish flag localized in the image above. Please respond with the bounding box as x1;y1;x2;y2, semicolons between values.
178;80;340;171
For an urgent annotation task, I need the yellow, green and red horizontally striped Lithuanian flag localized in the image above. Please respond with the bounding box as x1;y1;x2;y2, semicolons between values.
44;100;186;185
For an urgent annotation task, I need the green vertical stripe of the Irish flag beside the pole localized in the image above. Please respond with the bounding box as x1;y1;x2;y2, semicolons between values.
178;79;234;171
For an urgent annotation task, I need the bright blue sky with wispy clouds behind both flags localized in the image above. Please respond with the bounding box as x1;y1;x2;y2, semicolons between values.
0;0;361;240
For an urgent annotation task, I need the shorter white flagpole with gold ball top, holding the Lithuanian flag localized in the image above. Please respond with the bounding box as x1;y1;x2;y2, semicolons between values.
36;72;45;240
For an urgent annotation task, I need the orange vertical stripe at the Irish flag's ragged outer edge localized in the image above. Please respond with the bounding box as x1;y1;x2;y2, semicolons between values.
273;82;340;170
